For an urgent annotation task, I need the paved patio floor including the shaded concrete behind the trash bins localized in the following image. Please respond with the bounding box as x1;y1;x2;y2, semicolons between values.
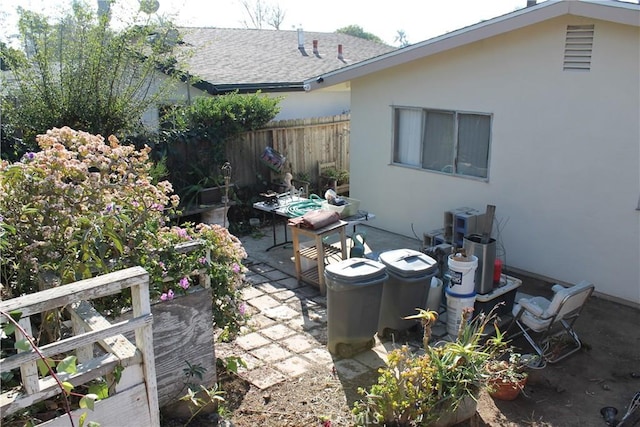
216;224;528;389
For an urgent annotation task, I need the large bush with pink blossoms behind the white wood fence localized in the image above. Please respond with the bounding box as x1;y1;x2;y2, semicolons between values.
0;127;246;342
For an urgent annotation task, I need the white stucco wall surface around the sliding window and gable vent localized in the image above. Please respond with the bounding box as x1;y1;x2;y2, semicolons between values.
350;17;640;303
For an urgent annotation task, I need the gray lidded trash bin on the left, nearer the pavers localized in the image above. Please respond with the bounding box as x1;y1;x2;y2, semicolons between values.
324;258;389;357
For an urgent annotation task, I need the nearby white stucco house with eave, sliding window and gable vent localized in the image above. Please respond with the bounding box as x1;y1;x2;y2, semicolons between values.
305;0;640;306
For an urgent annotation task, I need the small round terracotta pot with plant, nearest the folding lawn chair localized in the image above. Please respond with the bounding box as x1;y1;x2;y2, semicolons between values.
486;351;529;400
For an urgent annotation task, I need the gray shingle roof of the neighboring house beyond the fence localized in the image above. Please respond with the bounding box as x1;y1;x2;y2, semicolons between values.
179;28;396;94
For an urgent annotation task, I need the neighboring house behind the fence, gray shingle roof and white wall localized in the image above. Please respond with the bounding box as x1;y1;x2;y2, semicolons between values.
144;27;396;127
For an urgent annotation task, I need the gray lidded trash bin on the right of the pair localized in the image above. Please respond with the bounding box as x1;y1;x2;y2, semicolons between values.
378;249;438;337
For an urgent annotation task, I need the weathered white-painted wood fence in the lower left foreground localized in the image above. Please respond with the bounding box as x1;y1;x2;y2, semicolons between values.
0;267;160;427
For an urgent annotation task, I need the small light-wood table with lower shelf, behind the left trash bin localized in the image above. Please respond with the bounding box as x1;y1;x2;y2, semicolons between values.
289;221;348;295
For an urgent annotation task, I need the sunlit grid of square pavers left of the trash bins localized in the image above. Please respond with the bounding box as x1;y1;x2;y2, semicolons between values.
228;263;404;389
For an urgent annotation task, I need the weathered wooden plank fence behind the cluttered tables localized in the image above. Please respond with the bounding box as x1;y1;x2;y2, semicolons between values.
226;114;350;191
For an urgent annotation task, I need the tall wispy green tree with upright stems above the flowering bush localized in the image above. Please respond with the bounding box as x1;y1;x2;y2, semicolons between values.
2;1;184;160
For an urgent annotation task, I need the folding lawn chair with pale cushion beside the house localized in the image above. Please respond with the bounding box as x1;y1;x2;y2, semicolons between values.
509;280;595;367
